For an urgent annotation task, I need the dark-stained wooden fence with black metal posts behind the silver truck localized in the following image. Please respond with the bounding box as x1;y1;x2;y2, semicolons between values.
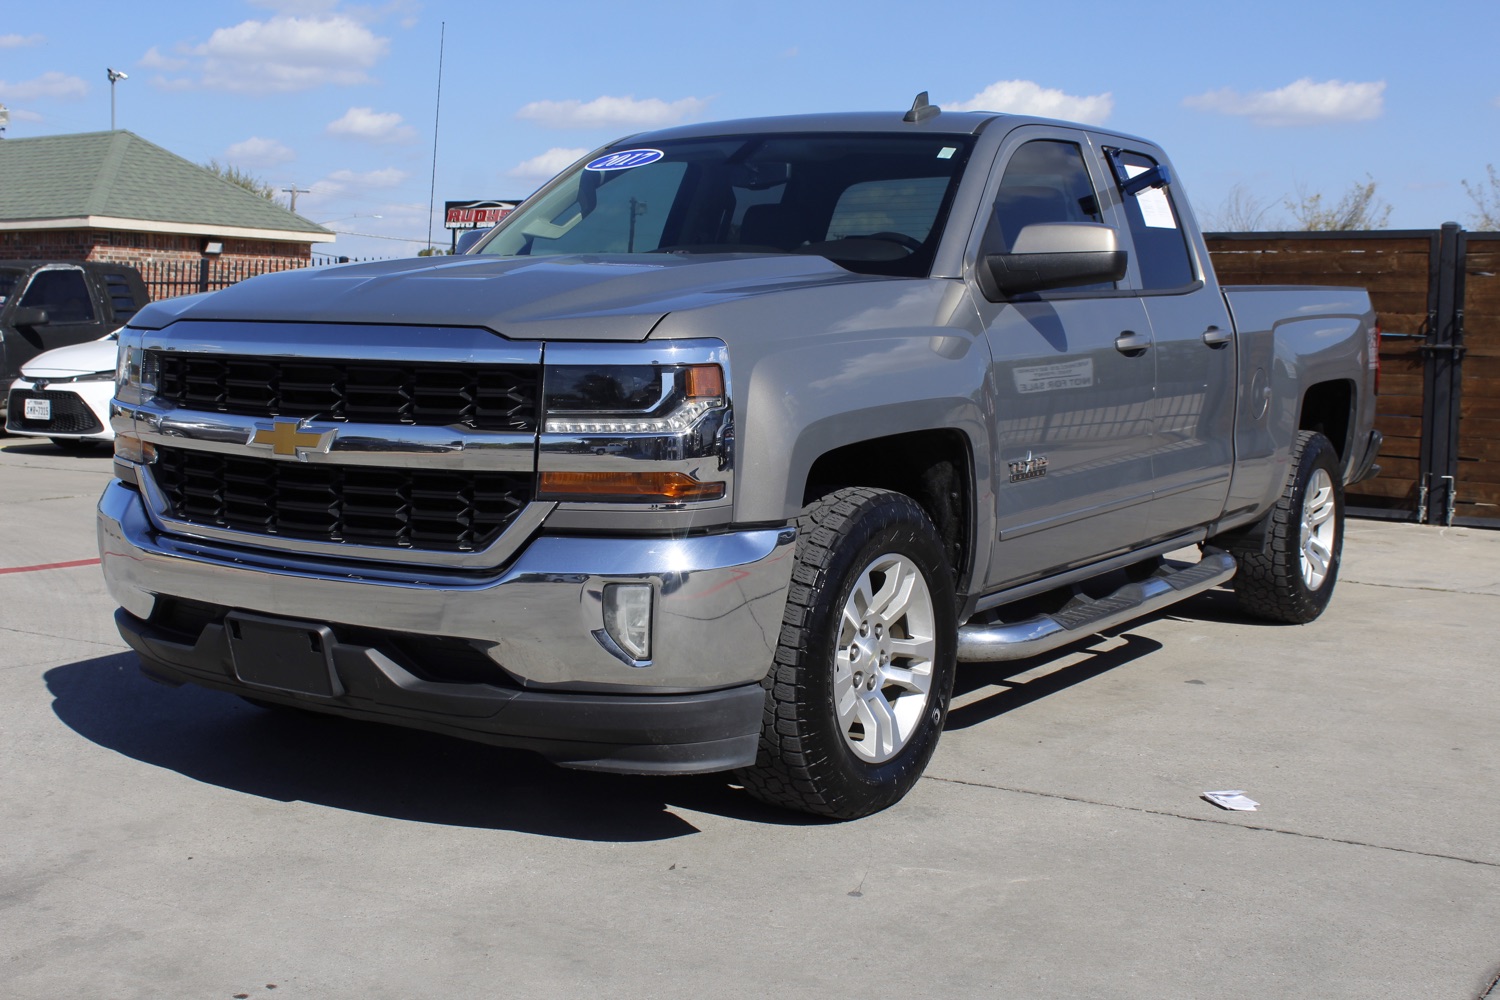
1208;223;1500;528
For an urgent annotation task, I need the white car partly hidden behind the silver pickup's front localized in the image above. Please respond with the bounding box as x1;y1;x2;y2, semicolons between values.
5;333;117;450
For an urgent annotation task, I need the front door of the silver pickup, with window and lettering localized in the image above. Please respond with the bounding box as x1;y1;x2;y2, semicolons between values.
971;126;1155;591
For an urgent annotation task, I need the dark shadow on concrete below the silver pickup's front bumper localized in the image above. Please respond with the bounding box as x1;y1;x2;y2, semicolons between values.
45;652;825;843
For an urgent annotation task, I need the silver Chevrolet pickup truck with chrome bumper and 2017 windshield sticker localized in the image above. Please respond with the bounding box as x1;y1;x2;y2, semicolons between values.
98;96;1379;817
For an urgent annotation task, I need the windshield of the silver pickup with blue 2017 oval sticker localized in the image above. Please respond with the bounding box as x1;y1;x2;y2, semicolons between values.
474;133;972;277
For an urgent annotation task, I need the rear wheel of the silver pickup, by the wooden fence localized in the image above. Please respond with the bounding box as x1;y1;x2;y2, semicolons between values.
1230;430;1344;624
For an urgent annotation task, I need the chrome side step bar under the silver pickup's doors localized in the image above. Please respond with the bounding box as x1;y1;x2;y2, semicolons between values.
959;552;1238;663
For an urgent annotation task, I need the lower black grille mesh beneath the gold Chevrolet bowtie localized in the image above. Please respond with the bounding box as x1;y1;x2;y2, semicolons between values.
150;447;531;552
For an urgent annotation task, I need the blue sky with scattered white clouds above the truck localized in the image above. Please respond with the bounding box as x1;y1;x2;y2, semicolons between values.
0;0;1500;259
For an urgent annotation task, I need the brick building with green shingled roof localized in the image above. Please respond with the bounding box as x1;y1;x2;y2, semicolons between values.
0;130;335;283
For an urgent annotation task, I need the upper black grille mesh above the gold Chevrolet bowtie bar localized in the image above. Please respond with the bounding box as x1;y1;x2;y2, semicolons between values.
147;351;540;433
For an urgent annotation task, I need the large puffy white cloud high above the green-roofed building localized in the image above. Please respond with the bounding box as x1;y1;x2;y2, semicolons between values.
159;13;390;93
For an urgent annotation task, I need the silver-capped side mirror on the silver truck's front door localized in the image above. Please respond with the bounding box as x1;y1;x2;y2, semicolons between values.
980;222;1130;301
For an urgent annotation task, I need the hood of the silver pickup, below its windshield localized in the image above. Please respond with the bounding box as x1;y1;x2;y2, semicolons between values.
131;253;879;340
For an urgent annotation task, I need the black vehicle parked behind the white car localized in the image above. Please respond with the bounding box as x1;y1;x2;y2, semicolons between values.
0;261;150;396
